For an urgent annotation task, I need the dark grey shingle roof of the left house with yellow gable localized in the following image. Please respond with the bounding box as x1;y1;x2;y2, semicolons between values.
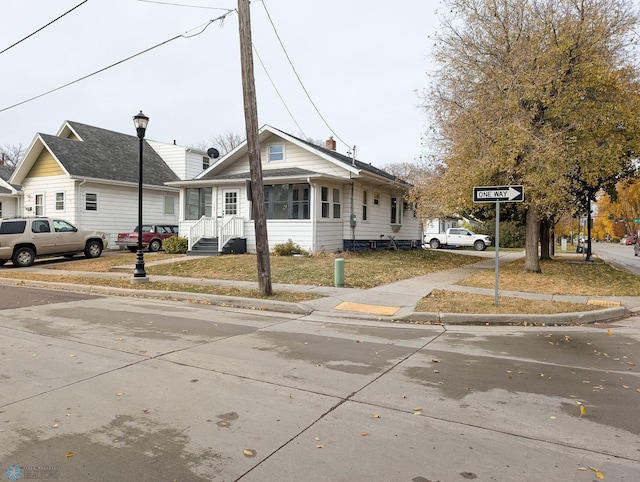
12;121;179;186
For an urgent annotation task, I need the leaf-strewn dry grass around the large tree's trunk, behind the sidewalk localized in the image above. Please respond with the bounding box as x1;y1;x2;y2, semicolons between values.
458;255;640;296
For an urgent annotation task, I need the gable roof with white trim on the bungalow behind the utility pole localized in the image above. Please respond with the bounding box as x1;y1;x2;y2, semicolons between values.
196;125;406;184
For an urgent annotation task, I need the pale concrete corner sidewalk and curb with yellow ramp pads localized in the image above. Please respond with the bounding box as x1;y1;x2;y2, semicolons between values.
0;251;640;325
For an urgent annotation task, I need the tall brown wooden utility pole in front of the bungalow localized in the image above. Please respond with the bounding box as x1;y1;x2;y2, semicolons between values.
238;0;273;296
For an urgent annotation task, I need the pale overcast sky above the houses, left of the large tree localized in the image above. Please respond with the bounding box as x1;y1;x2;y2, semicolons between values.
0;0;438;167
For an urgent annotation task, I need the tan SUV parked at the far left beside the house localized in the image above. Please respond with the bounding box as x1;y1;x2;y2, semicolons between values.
0;217;109;267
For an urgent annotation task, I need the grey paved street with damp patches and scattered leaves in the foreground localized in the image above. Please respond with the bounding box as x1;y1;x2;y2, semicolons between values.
0;286;640;482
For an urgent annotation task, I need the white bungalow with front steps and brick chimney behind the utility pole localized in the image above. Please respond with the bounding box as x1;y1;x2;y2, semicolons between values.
167;125;422;253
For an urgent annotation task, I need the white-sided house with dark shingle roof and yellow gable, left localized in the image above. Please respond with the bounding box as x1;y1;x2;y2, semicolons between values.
10;121;206;245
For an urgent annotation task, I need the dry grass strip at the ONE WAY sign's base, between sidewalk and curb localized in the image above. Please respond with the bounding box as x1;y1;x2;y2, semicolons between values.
416;290;602;315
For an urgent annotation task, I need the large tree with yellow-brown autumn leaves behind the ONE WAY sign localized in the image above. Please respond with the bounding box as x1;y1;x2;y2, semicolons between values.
414;0;640;272
